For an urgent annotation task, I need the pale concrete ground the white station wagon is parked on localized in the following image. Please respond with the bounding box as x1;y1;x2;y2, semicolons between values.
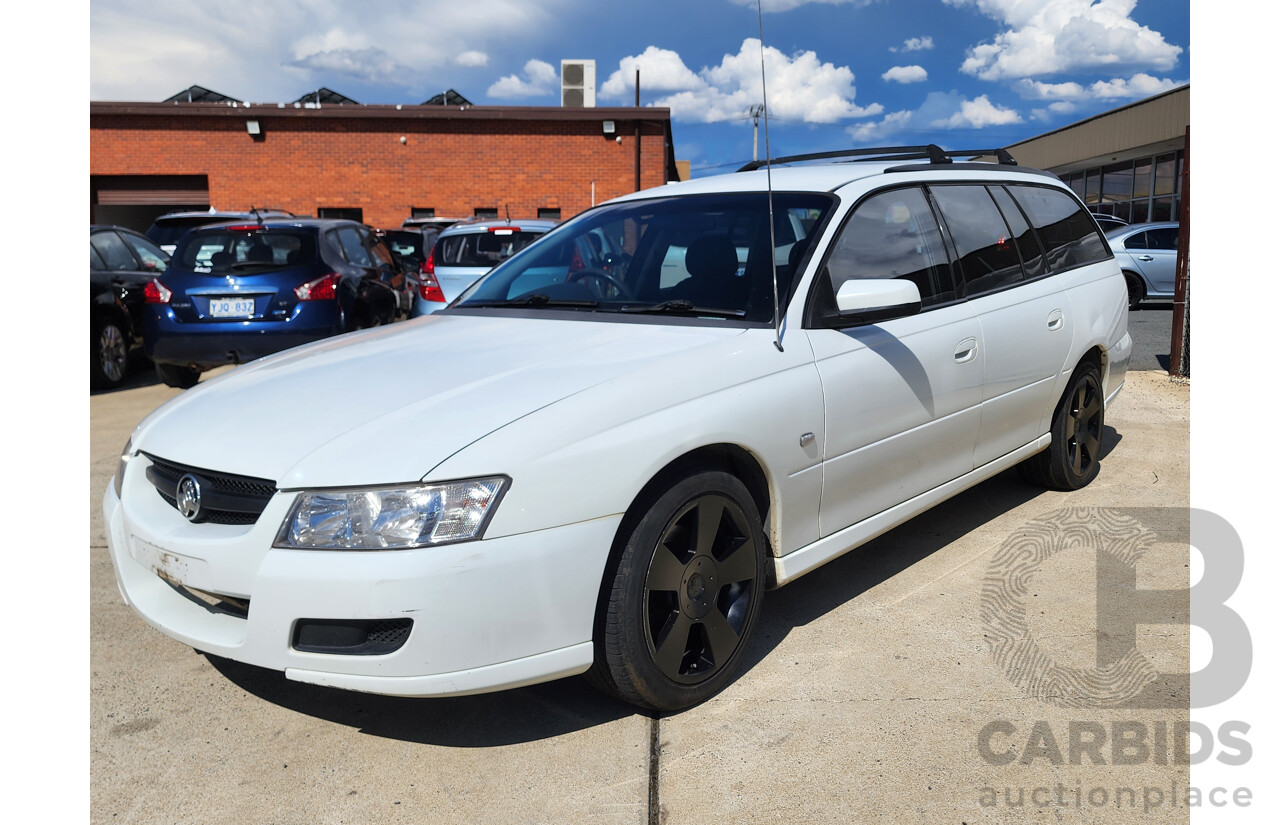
90;347;1189;825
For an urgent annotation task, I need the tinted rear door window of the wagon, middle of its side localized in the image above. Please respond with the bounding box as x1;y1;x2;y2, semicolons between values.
929;184;1023;297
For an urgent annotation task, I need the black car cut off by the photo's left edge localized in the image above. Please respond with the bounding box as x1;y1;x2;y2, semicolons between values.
88;225;169;389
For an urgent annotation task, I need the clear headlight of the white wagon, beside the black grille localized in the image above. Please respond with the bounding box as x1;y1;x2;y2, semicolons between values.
275;476;511;550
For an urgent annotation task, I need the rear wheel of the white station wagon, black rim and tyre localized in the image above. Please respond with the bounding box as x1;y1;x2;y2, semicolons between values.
1020;362;1106;491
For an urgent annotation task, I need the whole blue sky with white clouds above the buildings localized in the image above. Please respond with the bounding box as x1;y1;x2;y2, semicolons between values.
90;0;1190;175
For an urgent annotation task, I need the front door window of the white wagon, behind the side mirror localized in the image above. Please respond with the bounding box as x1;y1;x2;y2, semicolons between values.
823;188;955;307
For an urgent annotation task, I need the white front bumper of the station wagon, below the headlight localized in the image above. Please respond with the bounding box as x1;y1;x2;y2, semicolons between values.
102;455;620;696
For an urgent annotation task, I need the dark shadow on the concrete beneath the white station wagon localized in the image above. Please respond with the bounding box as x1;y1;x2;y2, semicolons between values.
206;427;1121;747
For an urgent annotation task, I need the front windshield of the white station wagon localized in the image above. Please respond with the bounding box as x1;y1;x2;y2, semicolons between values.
454;192;833;322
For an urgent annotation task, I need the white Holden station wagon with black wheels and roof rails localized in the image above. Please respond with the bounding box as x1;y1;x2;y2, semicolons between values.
102;147;1132;710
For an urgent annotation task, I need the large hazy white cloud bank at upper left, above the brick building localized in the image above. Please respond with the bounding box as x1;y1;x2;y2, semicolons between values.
88;0;565;102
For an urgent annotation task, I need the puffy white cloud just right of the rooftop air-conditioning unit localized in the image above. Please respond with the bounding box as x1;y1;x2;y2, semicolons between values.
600;37;883;123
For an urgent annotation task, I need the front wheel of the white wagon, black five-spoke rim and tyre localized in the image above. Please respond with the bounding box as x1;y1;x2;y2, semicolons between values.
591;471;765;711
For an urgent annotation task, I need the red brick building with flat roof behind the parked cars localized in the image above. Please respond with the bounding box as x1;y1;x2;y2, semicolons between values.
90;101;677;229
